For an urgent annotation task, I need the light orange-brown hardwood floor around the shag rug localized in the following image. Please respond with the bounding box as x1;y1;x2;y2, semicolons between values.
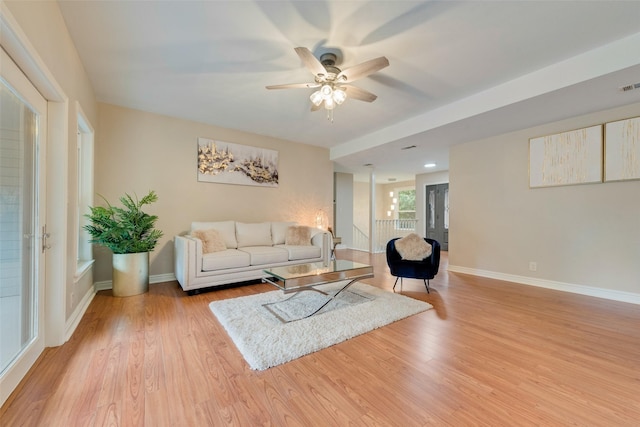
0;250;640;427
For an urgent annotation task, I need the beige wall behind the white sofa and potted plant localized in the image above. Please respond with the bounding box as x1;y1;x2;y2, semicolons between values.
95;104;333;282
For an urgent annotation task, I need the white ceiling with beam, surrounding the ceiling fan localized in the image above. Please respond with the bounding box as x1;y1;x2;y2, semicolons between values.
59;0;640;182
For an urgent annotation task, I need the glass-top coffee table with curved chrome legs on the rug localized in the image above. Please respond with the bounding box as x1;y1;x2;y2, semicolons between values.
262;259;373;323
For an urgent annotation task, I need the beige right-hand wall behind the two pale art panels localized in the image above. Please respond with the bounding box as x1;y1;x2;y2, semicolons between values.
449;104;640;293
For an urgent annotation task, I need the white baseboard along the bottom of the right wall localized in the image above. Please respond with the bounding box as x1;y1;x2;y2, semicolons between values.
448;265;640;304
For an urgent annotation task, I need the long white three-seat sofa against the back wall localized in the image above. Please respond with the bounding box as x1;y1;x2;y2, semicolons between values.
174;221;332;294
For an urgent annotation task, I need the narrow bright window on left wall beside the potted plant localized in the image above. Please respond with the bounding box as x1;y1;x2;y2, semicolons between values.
76;106;93;275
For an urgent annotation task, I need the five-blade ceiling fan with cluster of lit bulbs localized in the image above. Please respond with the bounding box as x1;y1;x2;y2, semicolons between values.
267;47;389;122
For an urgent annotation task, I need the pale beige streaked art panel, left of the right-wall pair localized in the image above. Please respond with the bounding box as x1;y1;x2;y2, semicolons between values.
529;125;603;188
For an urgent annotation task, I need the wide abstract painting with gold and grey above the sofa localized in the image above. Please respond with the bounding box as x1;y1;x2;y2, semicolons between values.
198;138;278;187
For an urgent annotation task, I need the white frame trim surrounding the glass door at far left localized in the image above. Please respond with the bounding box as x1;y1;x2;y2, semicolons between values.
0;5;68;405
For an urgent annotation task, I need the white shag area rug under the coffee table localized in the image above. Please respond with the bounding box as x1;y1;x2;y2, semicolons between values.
209;282;432;370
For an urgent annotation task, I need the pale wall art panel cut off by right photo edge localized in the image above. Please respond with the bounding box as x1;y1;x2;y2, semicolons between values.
604;117;640;181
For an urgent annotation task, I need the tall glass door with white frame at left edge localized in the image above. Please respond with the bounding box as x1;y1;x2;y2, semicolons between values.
0;50;47;404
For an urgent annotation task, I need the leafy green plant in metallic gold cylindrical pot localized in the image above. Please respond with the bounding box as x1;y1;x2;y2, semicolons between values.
84;191;162;297
